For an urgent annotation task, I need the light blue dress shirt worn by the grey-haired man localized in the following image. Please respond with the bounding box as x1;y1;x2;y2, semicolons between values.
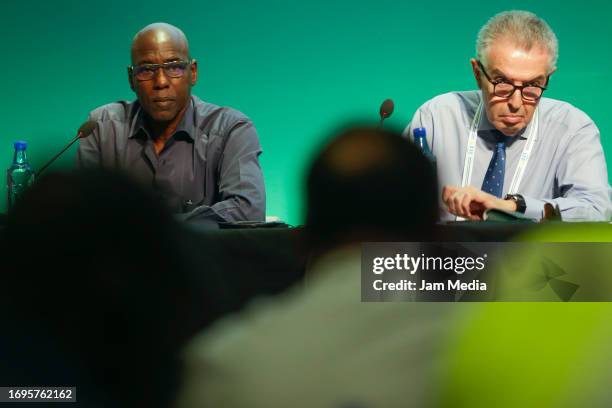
405;91;612;221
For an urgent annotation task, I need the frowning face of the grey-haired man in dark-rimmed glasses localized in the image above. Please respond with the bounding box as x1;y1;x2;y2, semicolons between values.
471;39;554;136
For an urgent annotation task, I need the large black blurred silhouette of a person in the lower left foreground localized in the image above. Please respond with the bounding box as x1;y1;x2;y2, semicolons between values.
0;171;206;407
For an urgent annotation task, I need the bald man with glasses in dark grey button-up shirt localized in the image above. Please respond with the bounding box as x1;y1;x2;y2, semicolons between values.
77;23;266;222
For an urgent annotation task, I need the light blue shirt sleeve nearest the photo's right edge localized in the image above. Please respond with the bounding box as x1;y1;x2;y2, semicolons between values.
525;121;612;221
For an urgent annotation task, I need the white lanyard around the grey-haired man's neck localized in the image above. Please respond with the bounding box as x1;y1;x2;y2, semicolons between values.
461;100;538;194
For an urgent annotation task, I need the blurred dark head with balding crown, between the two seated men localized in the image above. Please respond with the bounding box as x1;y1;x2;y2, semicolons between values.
306;127;438;249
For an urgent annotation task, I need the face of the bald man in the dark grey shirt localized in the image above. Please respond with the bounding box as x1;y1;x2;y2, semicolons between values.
129;31;197;123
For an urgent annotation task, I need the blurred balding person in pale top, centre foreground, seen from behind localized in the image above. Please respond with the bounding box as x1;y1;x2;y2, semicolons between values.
177;128;456;408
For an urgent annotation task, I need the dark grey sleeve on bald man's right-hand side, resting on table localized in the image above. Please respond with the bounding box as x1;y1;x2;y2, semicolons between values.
181;121;266;222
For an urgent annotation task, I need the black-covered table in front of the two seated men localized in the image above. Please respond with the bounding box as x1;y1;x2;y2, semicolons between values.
0;216;537;328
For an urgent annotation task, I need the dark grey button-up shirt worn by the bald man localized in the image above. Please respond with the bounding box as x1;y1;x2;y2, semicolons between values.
76;96;266;221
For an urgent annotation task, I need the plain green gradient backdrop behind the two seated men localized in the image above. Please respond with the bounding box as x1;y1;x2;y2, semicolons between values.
0;0;612;224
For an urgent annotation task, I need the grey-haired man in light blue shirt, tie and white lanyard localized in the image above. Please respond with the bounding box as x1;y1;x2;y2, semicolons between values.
406;11;612;221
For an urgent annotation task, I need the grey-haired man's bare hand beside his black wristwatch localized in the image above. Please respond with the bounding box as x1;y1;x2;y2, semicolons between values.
442;185;516;221
